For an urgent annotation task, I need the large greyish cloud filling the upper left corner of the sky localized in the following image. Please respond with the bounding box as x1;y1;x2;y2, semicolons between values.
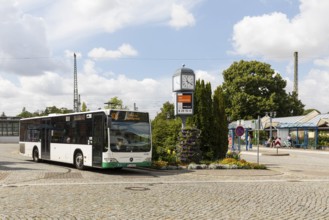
0;1;67;75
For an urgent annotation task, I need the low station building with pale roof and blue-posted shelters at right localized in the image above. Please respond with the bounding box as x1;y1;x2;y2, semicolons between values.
229;111;329;150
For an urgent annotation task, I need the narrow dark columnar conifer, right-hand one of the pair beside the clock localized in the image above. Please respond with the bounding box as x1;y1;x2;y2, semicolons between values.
213;86;228;159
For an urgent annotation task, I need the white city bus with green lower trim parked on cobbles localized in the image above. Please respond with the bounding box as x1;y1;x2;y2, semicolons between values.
19;110;152;169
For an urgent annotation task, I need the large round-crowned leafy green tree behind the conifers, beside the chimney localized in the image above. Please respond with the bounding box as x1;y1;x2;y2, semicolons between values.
223;60;304;120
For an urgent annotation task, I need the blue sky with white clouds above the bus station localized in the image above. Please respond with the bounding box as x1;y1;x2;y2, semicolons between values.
0;0;329;117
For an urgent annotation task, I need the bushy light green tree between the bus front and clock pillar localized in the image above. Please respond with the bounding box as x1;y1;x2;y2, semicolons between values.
152;102;182;160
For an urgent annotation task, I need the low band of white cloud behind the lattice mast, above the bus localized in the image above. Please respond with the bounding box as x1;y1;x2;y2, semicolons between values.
0;56;172;118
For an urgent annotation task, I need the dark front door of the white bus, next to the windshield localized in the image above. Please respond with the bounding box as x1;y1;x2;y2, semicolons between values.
92;114;105;167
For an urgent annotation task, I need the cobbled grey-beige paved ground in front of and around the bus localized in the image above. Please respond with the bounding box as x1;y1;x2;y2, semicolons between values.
0;145;329;219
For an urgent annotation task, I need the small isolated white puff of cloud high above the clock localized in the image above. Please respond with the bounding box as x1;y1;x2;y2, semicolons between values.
169;4;195;29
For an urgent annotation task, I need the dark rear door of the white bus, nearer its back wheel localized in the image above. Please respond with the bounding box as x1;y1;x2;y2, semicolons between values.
40;119;50;160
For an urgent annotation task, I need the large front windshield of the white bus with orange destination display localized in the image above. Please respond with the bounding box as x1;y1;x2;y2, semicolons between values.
110;111;151;152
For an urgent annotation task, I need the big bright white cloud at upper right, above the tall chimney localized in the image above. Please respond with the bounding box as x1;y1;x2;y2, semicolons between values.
232;0;329;59
